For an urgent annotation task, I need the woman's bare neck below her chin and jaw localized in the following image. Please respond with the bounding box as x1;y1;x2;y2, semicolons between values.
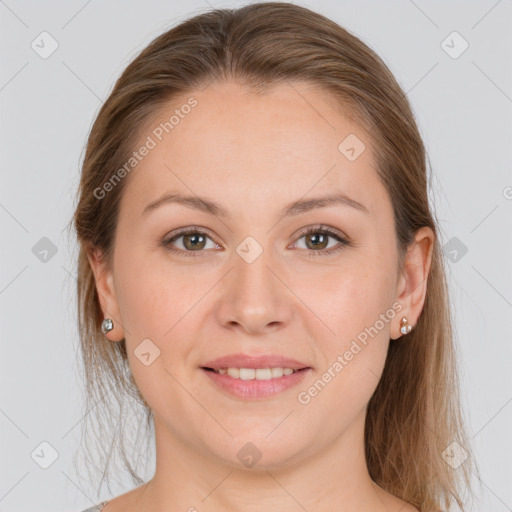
138;410;387;512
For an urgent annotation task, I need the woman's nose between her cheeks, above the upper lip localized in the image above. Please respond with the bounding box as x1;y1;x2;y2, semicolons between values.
216;244;294;335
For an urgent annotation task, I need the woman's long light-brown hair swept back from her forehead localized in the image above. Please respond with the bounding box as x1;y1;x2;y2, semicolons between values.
69;2;476;512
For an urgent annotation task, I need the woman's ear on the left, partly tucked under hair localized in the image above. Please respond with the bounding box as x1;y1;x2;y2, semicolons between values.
86;248;125;341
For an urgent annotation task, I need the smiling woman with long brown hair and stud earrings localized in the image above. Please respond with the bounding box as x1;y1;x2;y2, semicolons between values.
74;2;473;512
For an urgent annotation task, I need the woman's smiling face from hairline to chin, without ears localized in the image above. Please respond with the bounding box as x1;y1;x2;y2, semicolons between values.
90;83;418;468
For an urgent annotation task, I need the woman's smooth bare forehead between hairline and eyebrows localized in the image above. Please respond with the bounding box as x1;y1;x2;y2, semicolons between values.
118;82;385;221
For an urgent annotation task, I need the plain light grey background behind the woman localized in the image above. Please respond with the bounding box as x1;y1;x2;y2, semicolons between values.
0;0;512;512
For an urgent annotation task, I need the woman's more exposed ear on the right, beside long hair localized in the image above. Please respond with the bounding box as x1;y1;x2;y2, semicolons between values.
391;226;435;340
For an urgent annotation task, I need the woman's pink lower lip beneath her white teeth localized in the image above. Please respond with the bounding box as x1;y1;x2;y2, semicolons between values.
201;368;311;399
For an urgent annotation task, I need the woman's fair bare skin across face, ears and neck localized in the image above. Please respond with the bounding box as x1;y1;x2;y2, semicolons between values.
89;82;434;512
